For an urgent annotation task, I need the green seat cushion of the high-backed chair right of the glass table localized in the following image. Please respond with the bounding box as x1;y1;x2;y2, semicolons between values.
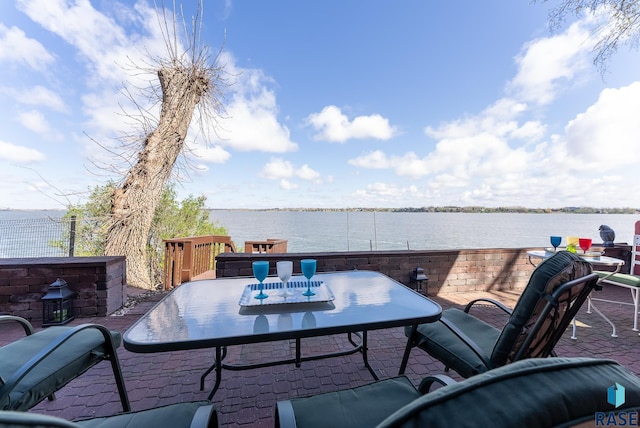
404;308;500;377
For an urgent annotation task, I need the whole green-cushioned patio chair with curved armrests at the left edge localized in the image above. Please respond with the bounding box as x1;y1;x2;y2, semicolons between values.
0;315;131;411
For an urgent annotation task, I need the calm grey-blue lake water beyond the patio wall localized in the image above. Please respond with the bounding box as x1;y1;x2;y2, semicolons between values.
0;210;640;257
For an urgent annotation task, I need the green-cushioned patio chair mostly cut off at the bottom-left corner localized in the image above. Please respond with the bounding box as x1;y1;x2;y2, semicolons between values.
0;401;218;428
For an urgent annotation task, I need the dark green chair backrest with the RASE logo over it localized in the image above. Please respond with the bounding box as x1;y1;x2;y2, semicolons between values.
378;358;640;428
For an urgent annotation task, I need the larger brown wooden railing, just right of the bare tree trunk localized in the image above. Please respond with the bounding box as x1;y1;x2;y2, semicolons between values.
163;235;236;290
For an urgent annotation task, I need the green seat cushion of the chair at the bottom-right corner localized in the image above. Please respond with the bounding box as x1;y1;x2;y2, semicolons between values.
276;376;420;428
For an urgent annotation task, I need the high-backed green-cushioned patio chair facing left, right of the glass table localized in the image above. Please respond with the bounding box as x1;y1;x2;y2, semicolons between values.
400;251;600;378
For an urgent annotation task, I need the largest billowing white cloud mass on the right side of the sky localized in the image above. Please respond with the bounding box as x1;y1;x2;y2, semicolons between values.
349;15;616;206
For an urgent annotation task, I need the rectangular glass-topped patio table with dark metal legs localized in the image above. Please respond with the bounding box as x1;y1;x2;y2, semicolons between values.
123;271;442;399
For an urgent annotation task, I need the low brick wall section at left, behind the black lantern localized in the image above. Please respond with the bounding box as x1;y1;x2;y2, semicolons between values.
0;256;127;322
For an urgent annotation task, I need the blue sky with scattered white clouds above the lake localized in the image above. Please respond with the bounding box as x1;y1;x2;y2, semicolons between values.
0;0;640;209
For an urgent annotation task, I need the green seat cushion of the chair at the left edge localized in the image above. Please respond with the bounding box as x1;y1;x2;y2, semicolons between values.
0;326;122;410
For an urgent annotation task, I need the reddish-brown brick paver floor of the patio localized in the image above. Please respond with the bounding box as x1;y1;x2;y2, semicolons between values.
0;286;640;427
